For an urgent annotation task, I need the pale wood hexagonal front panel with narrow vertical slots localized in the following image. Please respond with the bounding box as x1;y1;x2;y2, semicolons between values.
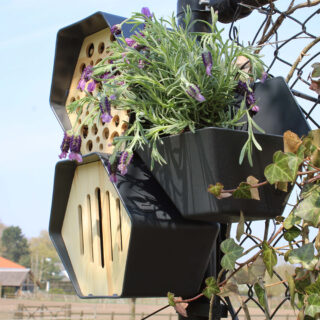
62;161;131;296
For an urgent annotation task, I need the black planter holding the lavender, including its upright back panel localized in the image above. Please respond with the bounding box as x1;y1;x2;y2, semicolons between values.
138;78;309;223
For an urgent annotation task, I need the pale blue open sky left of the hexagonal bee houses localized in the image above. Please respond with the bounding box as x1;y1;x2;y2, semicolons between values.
0;0;319;237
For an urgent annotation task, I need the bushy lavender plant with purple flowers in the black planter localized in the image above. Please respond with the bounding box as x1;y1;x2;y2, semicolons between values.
63;8;263;173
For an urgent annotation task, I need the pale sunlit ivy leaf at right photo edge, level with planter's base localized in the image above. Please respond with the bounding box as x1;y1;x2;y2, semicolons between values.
295;188;320;227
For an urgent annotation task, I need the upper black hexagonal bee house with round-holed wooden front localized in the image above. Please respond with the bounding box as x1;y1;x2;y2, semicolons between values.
50;12;129;155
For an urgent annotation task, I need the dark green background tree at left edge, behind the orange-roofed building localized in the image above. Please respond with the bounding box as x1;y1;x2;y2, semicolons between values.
1;226;29;267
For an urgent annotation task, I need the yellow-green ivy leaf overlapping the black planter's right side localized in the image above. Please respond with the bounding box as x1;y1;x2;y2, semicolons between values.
264;151;296;184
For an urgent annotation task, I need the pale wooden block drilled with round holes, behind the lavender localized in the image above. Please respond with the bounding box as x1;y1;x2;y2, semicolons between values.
66;28;129;155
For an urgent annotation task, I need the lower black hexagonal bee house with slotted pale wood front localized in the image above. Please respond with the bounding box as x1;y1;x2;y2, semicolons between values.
49;154;219;297
